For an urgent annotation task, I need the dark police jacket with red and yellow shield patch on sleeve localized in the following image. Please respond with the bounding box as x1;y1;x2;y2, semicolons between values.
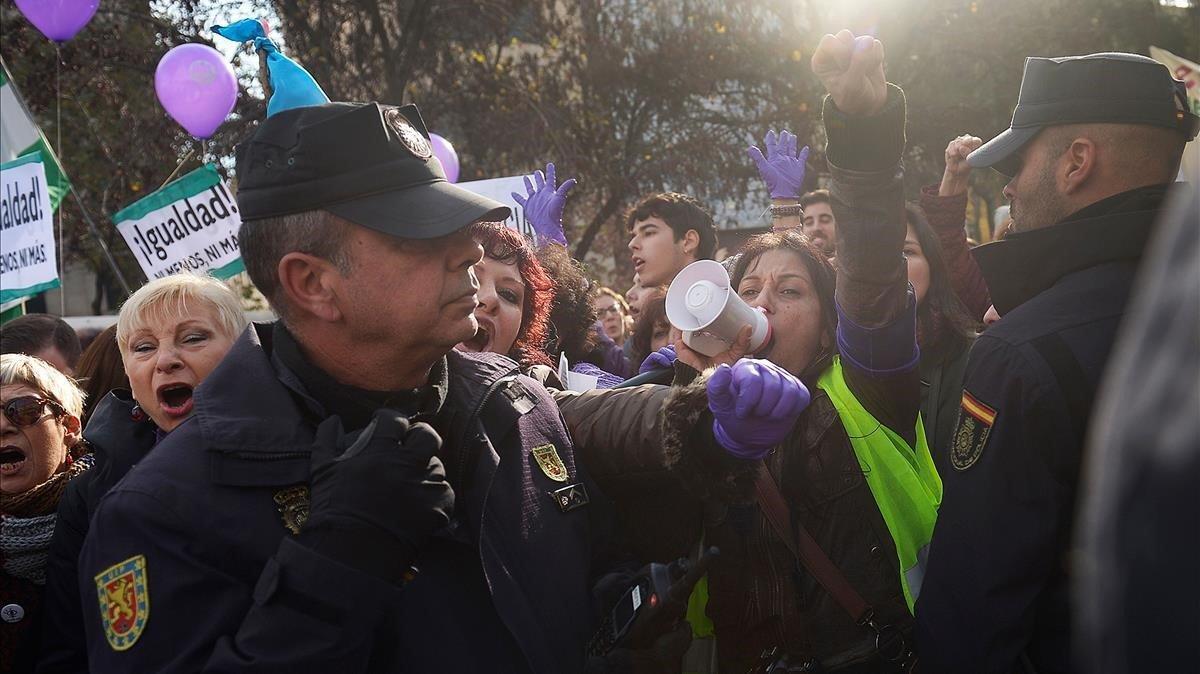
79;326;596;674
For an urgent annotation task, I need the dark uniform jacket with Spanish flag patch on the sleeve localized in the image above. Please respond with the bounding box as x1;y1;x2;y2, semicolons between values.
916;186;1166;674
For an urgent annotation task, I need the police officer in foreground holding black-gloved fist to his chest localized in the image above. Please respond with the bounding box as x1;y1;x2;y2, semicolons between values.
79;103;602;674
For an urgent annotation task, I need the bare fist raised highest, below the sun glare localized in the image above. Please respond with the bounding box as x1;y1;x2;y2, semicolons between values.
812;30;888;116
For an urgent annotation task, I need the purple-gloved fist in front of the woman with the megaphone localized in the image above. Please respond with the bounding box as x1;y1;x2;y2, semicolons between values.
708;359;810;459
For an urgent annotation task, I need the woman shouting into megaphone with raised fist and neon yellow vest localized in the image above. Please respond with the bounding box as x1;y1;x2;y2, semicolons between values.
560;31;941;673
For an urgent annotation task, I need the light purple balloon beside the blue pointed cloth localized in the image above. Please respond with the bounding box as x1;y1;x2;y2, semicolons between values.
154;44;238;138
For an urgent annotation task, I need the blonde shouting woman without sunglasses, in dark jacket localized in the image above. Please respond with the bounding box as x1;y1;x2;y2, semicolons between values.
40;273;247;672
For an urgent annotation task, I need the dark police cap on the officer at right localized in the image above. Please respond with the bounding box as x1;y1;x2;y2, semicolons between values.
967;53;1200;175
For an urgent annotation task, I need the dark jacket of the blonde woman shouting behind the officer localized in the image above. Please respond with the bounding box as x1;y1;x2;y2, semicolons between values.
37;390;157;674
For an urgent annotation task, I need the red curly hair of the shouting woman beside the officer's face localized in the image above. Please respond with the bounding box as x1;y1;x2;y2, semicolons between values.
470;222;554;367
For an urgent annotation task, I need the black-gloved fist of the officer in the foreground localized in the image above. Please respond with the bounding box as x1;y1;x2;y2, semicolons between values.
300;409;454;584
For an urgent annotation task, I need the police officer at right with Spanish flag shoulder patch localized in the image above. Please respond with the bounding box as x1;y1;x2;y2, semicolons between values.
916;54;1196;674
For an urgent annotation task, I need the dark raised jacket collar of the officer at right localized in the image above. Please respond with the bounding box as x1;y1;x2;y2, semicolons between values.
972;185;1169;315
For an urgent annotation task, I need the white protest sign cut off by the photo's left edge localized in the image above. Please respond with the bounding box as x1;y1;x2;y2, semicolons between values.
0;152;60;305
